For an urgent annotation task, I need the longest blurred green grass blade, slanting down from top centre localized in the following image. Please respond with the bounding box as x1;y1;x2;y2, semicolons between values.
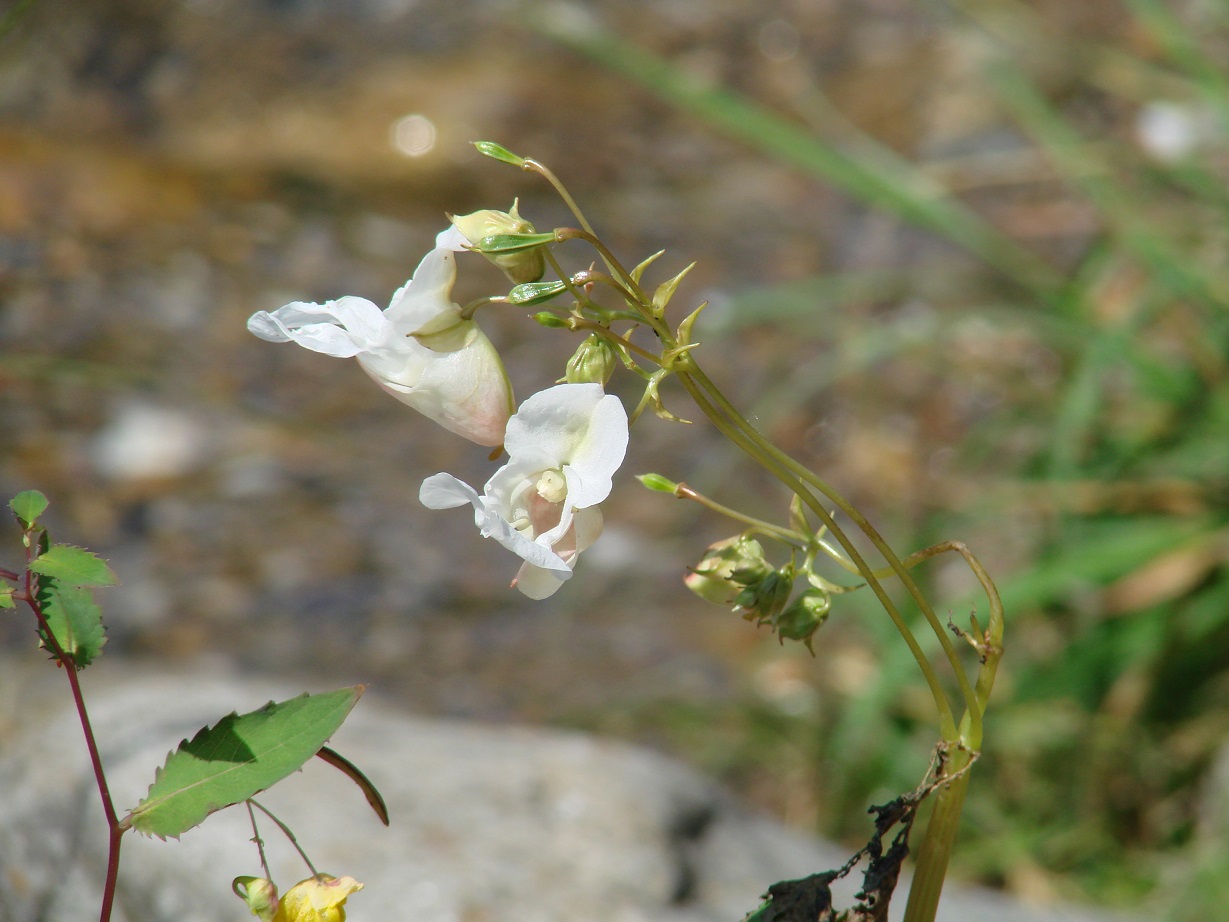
528;5;1062;300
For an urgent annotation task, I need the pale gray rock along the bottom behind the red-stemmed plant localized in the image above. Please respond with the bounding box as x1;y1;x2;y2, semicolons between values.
0;663;1135;922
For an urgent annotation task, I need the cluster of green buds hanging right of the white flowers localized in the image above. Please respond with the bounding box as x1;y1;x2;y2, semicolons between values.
683;535;832;653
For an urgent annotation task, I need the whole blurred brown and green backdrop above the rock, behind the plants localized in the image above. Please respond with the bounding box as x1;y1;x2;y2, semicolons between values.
0;0;1229;920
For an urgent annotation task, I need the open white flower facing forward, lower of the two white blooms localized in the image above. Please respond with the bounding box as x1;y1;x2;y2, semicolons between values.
418;384;627;599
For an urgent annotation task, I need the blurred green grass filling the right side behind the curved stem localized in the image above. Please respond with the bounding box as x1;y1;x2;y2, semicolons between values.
541;0;1229;918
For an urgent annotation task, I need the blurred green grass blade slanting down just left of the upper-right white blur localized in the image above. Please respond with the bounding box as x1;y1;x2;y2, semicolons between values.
988;63;1225;311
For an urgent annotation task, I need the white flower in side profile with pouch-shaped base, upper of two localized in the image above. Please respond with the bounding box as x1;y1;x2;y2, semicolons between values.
247;242;512;445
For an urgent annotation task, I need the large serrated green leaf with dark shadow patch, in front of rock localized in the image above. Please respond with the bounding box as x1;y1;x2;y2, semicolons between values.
124;685;364;838
